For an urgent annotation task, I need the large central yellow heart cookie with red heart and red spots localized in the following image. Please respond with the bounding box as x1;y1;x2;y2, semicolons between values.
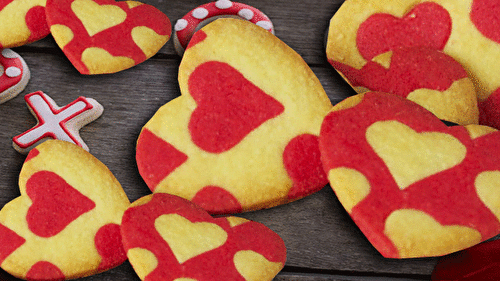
137;19;331;213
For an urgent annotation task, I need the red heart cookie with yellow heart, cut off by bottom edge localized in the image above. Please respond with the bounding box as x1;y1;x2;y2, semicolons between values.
121;193;286;281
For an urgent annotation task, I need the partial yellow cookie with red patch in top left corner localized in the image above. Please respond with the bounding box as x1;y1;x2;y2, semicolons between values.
0;0;50;49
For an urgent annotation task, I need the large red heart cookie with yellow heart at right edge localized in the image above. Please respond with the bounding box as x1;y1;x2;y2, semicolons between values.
320;92;500;258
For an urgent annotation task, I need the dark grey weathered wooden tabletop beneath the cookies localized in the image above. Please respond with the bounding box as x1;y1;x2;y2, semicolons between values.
0;0;436;281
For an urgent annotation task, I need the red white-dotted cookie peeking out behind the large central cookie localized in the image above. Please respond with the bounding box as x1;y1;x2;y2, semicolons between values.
173;0;274;56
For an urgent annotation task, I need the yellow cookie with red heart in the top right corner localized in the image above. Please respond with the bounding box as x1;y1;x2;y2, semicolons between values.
326;0;500;128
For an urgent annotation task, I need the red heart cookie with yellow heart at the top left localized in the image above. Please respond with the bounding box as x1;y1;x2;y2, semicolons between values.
46;0;172;74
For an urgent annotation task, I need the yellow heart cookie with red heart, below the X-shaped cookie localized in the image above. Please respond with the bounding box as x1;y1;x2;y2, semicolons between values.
0;140;130;280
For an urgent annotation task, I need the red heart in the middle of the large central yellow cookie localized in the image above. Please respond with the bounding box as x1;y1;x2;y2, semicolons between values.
188;61;284;153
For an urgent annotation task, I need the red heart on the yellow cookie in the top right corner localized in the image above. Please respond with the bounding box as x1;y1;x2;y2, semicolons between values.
356;2;452;60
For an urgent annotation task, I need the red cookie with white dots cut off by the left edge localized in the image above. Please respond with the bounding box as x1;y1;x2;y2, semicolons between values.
0;49;30;104
